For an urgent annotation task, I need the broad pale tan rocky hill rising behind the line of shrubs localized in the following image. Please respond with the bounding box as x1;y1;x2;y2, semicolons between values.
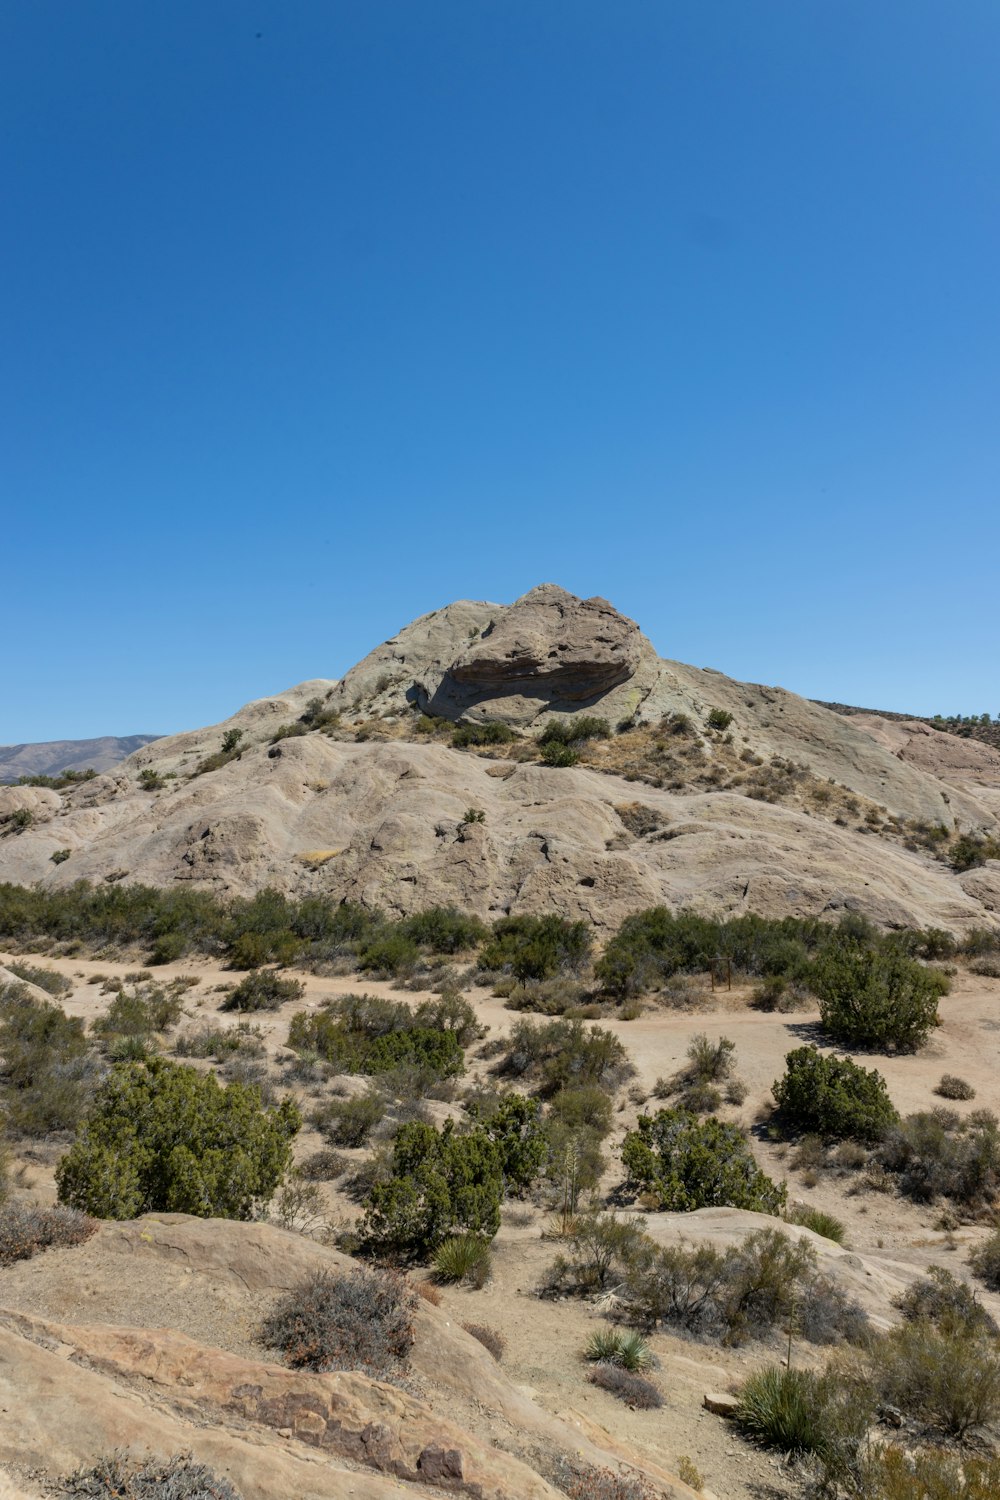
0;585;1000;930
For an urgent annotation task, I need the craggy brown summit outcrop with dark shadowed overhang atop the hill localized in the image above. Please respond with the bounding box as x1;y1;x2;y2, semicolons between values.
430;584;645;719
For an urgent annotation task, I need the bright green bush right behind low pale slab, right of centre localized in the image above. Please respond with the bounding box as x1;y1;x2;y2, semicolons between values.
622;1110;786;1214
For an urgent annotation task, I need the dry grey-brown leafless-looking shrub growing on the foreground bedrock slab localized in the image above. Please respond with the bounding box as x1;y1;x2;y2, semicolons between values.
261;1266;417;1379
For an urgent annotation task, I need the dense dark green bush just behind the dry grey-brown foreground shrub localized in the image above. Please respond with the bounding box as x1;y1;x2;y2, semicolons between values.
361;1121;504;1259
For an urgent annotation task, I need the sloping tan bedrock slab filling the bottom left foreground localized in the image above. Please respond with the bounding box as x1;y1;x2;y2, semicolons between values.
0;1215;701;1500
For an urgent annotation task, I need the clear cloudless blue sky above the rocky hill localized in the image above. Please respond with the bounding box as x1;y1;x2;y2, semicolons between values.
0;0;1000;743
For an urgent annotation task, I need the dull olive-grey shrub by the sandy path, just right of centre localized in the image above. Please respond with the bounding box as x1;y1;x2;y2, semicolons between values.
499;1020;634;1098
